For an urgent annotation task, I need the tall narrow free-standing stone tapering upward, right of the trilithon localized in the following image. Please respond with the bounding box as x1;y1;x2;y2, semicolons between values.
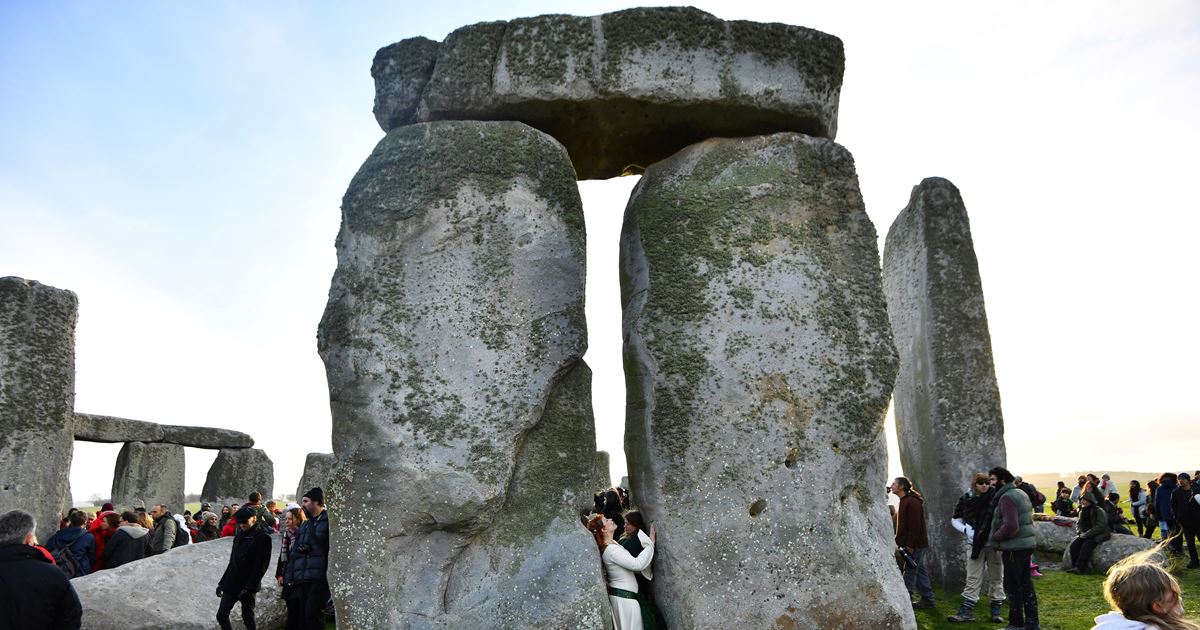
883;178;1007;590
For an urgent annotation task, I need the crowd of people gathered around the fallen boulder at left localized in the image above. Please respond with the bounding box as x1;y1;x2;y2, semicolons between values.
0;487;331;630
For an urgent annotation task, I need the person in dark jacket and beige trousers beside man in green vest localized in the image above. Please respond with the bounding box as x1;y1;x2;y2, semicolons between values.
946;473;1003;623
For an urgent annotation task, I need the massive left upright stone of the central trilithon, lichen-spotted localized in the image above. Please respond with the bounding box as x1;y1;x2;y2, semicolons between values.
318;121;608;628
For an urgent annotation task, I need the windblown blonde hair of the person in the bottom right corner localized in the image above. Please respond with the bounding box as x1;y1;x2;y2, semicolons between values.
1104;544;1200;630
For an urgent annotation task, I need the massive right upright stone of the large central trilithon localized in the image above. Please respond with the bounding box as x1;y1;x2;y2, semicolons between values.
620;133;916;629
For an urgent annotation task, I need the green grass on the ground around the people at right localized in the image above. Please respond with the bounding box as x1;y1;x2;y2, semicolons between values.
913;547;1200;630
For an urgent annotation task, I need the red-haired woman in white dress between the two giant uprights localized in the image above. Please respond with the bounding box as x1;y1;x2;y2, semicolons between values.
587;514;658;630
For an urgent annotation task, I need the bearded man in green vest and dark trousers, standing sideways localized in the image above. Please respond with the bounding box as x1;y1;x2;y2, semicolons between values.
988;466;1039;628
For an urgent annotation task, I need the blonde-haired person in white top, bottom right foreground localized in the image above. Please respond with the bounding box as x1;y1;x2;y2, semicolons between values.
1092;545;1200;630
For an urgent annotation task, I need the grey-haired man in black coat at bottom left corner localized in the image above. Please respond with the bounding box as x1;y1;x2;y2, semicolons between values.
0;510;83;630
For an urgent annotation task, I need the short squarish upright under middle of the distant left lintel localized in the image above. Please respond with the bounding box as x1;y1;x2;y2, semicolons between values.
112;442;184;514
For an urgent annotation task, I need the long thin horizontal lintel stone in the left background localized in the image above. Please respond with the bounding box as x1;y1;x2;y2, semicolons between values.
74;414;254;449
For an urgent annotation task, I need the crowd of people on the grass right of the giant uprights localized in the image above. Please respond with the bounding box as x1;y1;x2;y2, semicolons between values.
888;467;1200;630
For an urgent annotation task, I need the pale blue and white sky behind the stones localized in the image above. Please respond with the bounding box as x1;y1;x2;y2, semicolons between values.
0;0;1200;499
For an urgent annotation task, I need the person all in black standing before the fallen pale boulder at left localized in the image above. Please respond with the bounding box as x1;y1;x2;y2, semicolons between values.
217;508;271;630
